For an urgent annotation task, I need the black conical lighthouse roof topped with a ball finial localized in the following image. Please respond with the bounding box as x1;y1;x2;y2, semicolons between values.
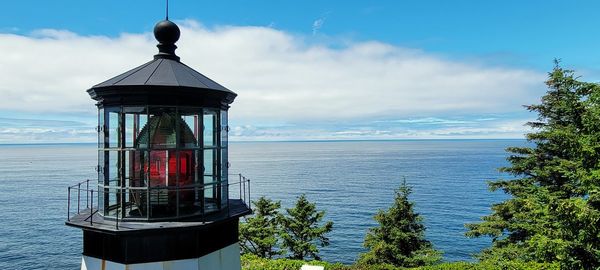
87;20;237;106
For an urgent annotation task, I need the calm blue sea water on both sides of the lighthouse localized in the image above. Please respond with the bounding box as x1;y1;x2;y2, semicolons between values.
0;140;525;269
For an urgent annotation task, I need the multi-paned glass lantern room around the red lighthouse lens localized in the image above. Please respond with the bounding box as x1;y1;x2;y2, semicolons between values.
97;105;229;221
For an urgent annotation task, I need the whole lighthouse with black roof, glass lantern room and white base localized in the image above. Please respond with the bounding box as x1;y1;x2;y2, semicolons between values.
66;20;251;270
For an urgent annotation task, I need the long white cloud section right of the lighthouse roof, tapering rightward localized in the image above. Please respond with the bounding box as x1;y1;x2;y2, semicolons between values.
180;22;545;122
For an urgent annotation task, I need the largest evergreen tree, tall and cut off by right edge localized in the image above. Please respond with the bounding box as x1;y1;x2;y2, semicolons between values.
466;62;600;269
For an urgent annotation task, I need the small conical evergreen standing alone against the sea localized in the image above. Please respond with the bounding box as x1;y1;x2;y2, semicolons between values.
359;180;441;267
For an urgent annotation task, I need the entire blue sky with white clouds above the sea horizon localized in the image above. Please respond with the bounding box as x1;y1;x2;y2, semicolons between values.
0;0;600;144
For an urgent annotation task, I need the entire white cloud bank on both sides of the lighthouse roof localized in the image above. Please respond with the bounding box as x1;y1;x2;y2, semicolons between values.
0;20;545;142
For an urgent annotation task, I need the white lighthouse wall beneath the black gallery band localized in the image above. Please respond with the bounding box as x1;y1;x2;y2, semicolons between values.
81;243;242;270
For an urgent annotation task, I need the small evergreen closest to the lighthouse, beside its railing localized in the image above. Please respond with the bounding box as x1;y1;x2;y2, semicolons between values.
239;196;283;258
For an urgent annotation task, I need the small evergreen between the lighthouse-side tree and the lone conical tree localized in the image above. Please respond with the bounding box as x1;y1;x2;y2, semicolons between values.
281;194;333;260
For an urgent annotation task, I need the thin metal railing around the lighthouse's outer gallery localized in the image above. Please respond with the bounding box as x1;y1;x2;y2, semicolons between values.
67;174;251;229
